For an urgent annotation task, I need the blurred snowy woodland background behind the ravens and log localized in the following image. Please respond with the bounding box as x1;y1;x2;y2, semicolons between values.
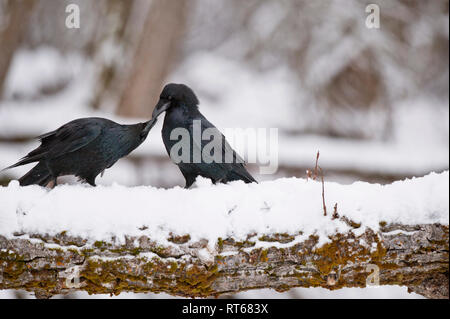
0;0;449;298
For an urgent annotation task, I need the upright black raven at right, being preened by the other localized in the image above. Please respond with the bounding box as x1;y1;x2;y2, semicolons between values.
152;83;256;188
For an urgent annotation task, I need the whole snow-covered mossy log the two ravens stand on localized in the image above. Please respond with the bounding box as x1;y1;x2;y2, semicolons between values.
0;172;449;298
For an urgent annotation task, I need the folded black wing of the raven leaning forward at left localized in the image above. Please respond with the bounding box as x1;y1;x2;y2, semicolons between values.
5;118;103;169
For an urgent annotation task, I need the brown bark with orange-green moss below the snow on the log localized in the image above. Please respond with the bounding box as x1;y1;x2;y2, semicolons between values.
0;221;449;298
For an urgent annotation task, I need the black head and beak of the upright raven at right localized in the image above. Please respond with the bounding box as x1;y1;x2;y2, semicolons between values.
152;83;199;119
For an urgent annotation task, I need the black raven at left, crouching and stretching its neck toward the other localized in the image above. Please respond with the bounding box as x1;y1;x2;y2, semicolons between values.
5;117;156;186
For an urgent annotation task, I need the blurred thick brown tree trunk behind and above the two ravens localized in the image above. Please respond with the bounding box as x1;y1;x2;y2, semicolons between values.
118;0;188;116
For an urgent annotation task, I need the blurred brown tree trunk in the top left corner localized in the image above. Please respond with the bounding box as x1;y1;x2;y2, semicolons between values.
0;0;35;98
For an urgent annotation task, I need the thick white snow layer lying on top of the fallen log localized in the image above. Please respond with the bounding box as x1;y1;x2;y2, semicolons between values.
0;171;449;249
